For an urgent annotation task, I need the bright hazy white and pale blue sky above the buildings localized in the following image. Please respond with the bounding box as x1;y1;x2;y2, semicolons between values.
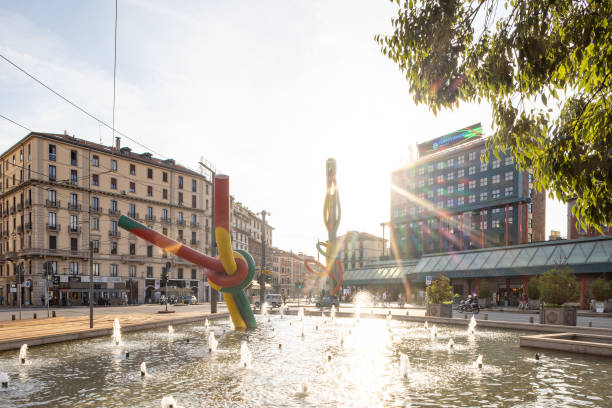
0;0;566;254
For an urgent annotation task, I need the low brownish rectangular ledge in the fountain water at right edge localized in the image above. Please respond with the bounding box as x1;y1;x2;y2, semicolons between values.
519;333;612;357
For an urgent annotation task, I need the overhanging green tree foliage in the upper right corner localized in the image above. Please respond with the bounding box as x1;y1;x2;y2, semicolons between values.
375;0;612;231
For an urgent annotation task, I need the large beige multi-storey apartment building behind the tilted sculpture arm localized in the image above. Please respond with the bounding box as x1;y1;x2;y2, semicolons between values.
0;132;212;305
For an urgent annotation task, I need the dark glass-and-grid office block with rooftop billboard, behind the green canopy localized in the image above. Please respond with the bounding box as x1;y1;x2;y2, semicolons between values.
389;124;546;259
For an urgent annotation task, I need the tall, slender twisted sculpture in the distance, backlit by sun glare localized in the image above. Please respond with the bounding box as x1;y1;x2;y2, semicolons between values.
304;159;343;296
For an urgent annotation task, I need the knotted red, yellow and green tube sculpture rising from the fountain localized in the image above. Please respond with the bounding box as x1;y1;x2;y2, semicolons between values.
119;175;257;329
